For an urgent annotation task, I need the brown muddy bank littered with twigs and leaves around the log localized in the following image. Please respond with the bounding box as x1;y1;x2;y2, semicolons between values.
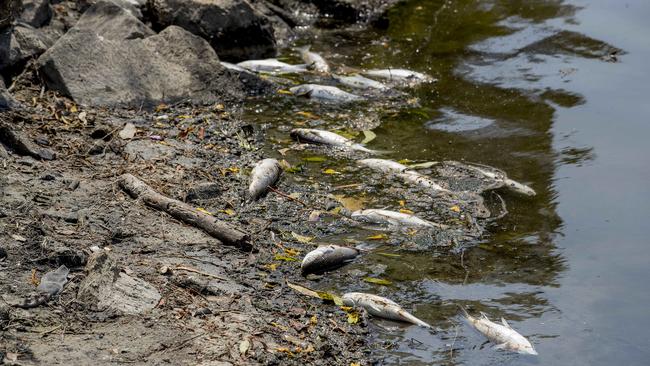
0;64;370;365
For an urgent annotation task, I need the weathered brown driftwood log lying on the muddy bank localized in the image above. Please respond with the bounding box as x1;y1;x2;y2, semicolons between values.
119;174;252;250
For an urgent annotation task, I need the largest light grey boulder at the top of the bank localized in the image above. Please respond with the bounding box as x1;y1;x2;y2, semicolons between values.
37;1;243;107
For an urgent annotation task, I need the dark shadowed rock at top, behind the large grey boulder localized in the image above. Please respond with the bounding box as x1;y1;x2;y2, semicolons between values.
149;0;276;61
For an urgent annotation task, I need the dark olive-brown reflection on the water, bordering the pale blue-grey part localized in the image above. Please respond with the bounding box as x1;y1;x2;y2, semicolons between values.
242;0;623;365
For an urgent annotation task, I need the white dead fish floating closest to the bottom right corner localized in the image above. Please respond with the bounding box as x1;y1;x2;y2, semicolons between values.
460;306;537;355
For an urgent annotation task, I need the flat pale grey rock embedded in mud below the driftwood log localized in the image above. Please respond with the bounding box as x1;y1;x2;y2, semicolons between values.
77;251;160;314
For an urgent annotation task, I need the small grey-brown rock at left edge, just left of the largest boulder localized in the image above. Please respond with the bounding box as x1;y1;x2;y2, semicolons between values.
0;25;58;71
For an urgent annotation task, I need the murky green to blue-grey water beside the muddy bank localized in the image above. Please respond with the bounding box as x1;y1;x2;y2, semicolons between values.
244;0;650;365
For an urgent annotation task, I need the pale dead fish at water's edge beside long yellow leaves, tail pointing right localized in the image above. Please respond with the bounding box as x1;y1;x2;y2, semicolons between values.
341;292;431;328
